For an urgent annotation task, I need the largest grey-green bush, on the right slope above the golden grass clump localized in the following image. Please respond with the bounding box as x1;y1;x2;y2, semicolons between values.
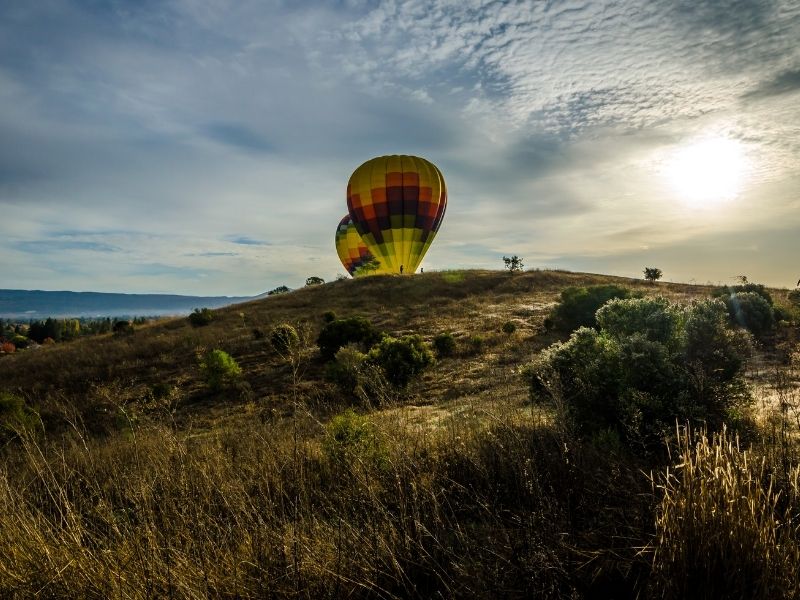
527;298;747;449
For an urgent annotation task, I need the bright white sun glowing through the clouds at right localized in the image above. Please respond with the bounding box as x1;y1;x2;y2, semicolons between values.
664;137;748;208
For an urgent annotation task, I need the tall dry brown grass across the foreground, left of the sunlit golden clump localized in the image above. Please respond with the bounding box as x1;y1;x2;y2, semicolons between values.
0;394;647;598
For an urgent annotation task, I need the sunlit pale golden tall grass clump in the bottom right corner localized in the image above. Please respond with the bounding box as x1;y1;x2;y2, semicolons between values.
653;430;800;600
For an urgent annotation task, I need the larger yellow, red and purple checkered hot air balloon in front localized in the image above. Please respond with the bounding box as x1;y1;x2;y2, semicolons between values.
347;155;447;274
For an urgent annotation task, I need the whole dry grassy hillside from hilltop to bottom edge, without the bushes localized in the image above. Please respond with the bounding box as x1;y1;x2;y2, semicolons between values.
0;271;800;598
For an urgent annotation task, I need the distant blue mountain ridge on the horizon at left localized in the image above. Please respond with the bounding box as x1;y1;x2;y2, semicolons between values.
0;289;253;320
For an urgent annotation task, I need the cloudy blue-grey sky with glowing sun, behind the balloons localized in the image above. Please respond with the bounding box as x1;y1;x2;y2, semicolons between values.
0;0;800;296
